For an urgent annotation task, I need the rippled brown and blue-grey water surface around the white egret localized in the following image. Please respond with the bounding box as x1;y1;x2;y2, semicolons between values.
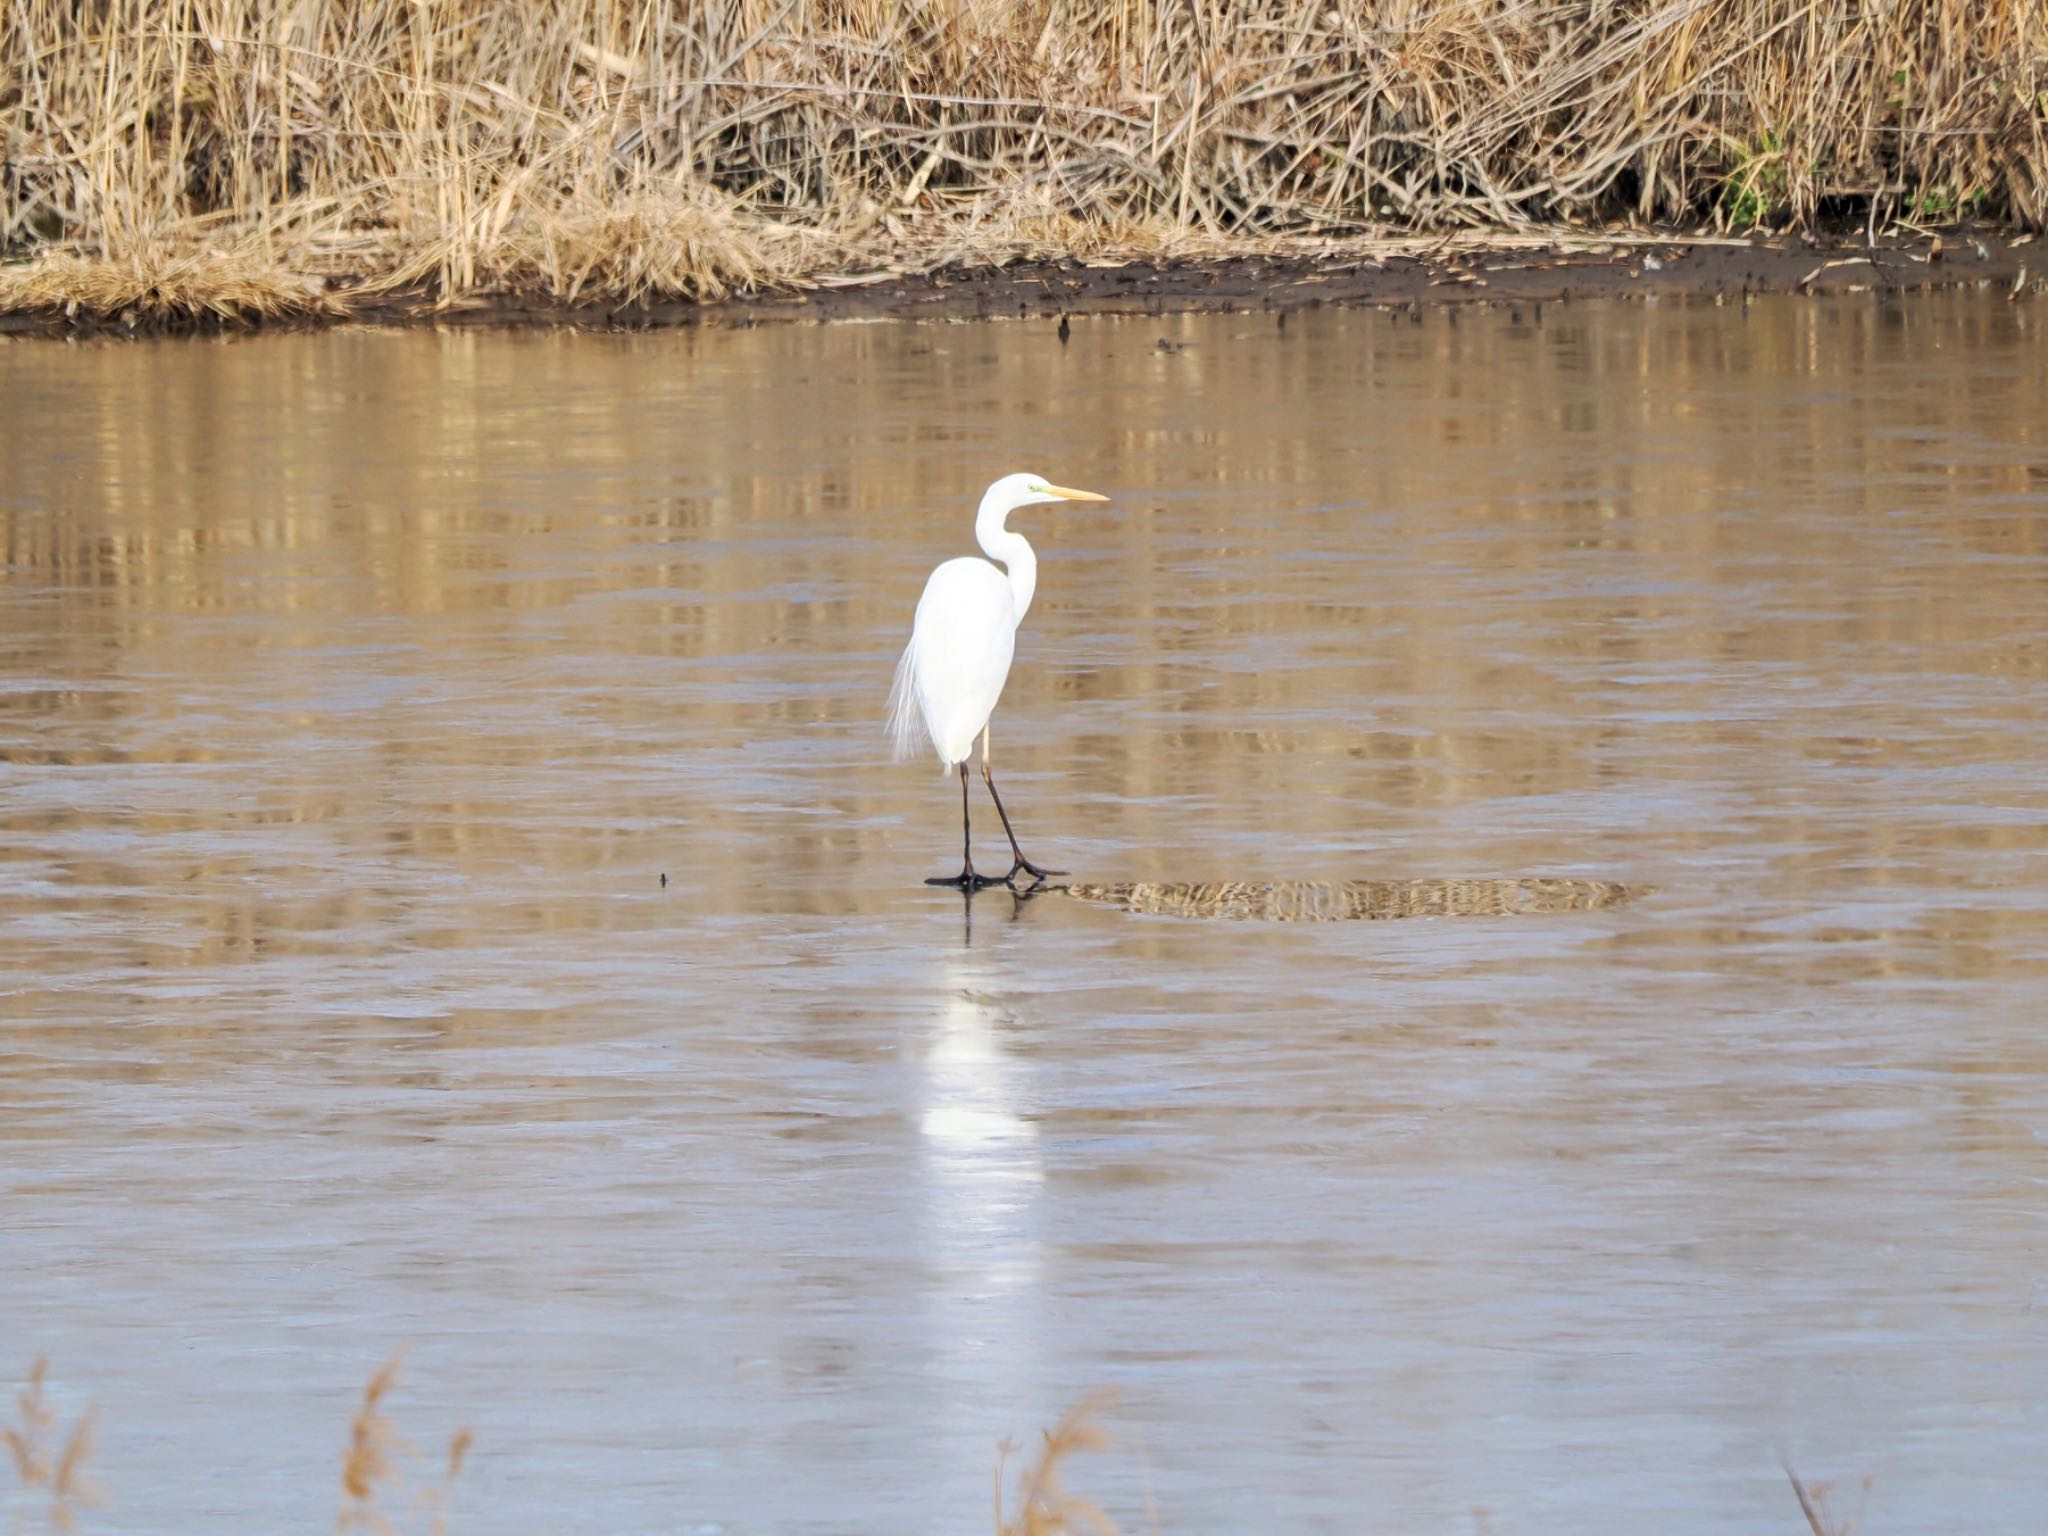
0;293;2048;1536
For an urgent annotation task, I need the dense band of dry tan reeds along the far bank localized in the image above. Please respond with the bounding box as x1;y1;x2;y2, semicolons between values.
0;0;2048;322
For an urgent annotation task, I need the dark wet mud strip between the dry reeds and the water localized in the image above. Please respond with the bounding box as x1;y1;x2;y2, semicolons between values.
0;229;2048;336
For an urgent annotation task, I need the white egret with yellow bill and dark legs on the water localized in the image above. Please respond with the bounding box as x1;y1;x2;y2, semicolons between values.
889;475;1110;891
